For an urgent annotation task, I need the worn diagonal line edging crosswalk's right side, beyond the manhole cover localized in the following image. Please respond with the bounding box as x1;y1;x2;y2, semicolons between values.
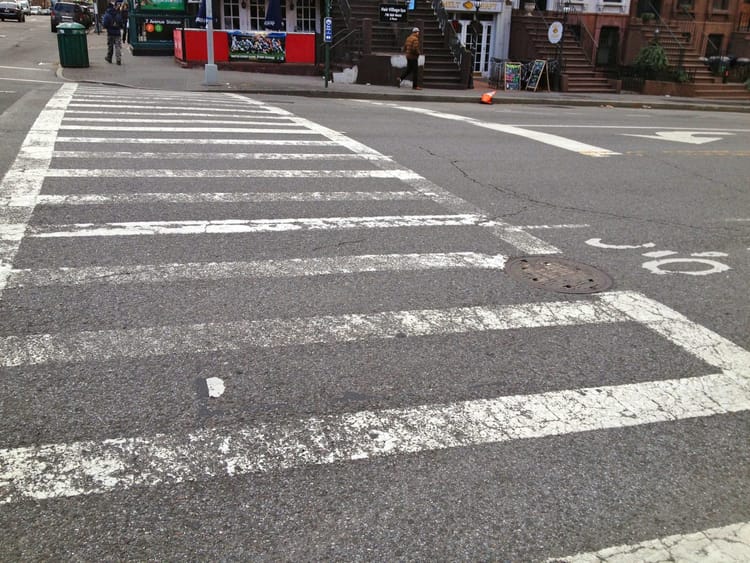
236;94;560;254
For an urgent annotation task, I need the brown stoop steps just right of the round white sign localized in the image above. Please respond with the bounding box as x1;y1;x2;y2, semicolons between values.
511;12;617;94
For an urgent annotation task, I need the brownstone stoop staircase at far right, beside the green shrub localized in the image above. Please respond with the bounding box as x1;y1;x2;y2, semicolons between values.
631;21;750;100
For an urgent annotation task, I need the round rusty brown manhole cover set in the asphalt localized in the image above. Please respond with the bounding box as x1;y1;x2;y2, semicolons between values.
505;256;613;293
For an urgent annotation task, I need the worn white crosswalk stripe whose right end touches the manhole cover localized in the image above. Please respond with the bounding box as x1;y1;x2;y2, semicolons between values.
7;252;506;289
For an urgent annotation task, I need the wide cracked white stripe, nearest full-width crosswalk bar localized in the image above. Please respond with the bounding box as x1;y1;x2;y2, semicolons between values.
0;374;750;503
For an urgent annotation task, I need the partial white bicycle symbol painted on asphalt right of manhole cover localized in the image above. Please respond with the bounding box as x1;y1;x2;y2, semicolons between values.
586;238;731;276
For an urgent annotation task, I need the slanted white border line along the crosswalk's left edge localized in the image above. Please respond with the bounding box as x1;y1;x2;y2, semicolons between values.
0;84;76;297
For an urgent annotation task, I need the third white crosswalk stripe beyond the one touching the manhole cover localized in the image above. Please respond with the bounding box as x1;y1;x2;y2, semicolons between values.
45;168;420;180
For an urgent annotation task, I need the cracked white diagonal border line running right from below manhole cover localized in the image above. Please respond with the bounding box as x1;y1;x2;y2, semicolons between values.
599;291;750;378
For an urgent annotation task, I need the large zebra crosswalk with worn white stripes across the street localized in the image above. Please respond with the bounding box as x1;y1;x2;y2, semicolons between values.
0;84;750;560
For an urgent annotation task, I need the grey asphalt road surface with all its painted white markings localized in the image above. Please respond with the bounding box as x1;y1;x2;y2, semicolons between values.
0;23;750;561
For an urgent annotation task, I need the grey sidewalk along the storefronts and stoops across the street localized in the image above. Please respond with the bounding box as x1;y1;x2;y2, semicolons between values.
58;33;750;113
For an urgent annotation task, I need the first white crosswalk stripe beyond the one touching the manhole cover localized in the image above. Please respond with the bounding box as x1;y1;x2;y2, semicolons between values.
28;215;482;238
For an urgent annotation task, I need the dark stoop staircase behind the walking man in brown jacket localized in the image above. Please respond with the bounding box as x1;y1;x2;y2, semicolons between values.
331;0;468;90
